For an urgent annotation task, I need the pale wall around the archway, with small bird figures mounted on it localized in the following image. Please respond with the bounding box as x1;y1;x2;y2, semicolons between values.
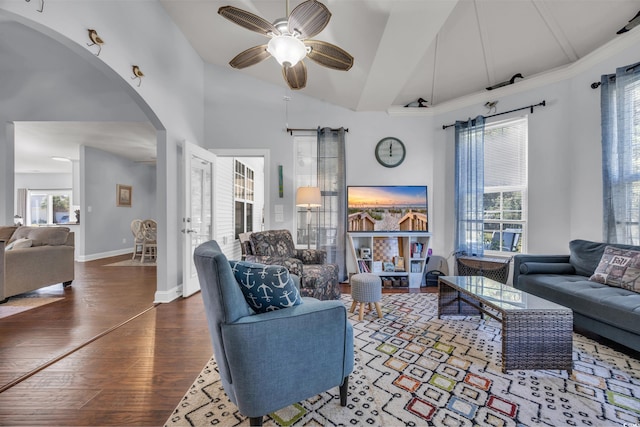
0;0;204;302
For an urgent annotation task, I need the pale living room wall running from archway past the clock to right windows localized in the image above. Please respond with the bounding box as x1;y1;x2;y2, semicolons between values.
5;0;639;300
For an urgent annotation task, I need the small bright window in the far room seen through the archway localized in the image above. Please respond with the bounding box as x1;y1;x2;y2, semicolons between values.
26;188;76;225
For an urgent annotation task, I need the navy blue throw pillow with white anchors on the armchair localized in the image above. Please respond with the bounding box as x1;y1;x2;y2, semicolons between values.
229;261;302;313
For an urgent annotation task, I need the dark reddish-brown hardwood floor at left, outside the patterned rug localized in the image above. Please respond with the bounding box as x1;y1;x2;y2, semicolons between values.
0;255;432;426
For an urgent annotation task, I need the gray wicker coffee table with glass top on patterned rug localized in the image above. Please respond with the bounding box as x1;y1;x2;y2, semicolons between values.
438;276;573;373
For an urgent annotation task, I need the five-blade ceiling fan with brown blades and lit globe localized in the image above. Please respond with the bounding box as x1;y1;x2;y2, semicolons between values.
218;0;353;89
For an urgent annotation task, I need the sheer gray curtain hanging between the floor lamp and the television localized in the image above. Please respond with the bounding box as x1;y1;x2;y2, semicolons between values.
316;128;347;281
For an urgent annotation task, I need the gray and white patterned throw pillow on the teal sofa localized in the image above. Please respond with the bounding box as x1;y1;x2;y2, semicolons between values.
589;246;640;292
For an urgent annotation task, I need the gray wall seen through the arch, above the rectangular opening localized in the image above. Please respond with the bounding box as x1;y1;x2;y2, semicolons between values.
0;18;147;224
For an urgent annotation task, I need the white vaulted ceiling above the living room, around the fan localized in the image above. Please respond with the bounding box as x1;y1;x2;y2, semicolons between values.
160;0;640;111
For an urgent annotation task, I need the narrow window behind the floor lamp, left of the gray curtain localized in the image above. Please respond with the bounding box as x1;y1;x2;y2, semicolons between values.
294;134;318;246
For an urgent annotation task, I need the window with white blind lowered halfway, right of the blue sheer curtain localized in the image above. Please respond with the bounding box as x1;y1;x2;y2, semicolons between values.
483;117;528;253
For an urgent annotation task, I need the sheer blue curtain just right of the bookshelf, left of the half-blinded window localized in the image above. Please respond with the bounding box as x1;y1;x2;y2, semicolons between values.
455;116;484;256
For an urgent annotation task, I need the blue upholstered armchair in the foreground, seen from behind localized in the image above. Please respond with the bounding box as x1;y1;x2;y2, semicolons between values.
194;240;353;425
